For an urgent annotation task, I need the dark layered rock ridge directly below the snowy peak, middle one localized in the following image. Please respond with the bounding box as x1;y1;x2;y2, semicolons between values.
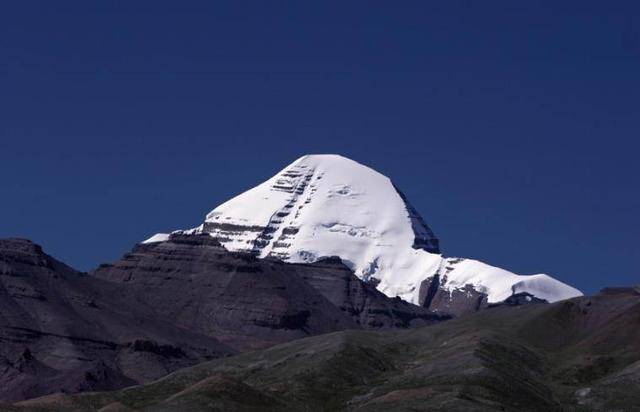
92;234;447;350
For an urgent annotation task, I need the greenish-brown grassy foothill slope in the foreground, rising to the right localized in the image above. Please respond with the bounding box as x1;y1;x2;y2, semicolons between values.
15;288;640;411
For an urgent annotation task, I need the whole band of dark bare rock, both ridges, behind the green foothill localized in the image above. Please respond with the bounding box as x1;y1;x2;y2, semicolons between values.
0;235;448;401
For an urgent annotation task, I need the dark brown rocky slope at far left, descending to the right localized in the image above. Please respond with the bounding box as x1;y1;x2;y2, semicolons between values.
0;239;235;400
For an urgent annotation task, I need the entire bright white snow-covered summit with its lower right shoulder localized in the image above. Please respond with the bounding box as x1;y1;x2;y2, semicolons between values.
145;155;581;303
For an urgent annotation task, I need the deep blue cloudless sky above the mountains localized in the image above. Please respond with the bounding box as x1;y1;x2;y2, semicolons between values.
0;1;640;292
